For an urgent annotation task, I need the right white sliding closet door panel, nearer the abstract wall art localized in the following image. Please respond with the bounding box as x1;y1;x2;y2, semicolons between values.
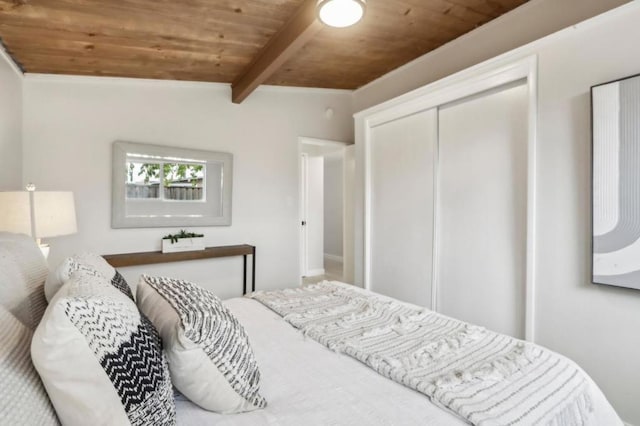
437;84;528;338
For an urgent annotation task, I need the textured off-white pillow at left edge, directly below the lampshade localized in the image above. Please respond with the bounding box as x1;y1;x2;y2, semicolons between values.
0;232;49;330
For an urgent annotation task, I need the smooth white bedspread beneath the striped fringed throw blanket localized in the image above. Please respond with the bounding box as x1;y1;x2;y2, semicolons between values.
176;298;622;426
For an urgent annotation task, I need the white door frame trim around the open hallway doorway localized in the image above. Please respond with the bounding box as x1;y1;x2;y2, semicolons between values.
298;136;349;283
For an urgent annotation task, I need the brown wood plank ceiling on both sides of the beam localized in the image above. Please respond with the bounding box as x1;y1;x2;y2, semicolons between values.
0;0;527;101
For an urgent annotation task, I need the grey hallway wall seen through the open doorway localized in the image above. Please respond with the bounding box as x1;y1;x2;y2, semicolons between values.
324;151;344;258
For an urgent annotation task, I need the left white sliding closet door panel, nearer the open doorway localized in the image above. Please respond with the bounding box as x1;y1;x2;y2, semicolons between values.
369;109;437;307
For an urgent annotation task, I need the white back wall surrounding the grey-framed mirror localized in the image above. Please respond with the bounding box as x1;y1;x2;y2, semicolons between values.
23;75;353;297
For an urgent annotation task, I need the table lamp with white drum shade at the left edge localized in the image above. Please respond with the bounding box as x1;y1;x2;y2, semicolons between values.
0;184;78;259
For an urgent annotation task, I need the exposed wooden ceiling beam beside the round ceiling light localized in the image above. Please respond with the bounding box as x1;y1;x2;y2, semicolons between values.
231;0;323;104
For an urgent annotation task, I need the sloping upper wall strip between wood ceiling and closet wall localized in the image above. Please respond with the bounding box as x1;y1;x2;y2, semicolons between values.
354;0;630;111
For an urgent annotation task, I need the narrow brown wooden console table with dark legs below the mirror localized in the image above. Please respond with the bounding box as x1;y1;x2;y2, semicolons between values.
102;244;256;294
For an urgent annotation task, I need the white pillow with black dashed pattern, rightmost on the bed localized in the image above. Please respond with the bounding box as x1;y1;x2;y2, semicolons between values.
137;275;267;413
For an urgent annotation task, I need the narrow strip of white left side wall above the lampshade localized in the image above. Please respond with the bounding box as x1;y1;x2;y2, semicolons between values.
0;46;23;191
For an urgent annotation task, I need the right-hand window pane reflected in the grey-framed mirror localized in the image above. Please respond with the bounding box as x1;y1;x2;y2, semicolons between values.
164;163;206;201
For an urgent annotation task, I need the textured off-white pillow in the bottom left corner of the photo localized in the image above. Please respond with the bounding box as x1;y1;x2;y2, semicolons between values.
0;306;59;426
